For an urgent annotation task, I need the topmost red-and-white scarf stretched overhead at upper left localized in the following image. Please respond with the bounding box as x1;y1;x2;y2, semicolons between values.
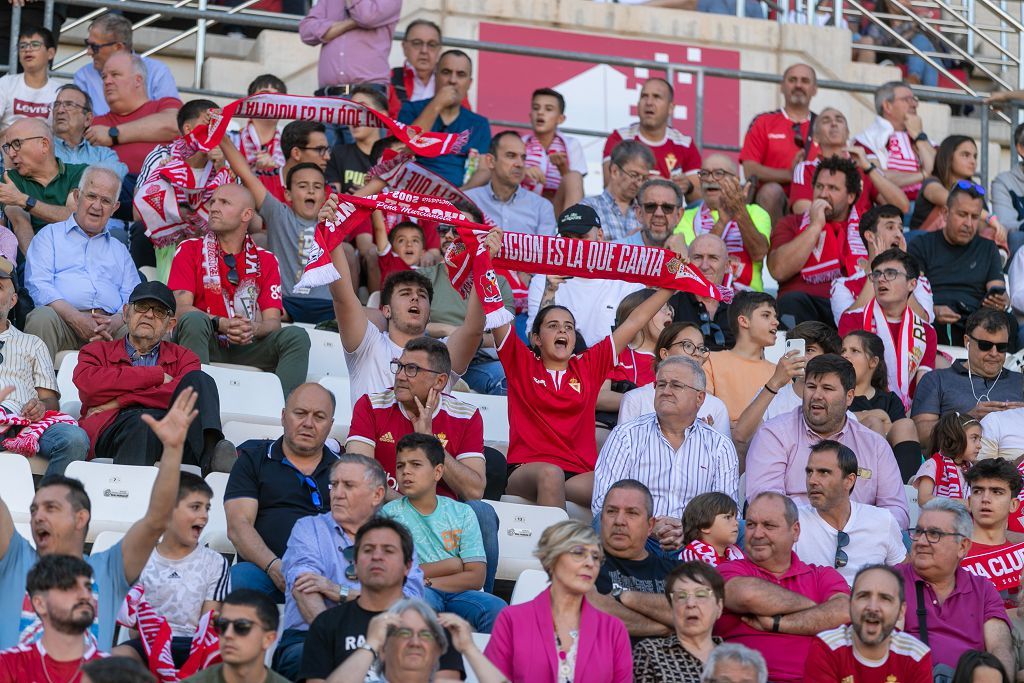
194;92;469;157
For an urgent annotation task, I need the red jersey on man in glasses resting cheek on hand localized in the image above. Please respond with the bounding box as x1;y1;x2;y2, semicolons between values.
348;389;483;498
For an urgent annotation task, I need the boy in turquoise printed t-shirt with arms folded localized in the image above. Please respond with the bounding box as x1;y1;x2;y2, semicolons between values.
381;432;507;633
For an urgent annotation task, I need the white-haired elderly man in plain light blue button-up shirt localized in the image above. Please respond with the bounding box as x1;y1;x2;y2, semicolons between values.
25;166;139;358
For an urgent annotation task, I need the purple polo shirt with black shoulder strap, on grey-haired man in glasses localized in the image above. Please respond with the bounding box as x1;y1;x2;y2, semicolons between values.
894;562;1010;668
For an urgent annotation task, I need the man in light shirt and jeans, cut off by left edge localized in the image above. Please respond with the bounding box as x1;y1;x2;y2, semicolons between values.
0;257;89;474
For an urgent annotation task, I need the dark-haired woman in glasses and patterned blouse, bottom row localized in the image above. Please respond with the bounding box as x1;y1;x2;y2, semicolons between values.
633;562;725;683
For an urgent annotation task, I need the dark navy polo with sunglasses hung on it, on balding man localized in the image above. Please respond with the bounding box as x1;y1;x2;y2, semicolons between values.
224;438;338;559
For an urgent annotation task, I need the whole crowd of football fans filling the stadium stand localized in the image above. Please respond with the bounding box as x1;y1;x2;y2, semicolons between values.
0;5;1024;683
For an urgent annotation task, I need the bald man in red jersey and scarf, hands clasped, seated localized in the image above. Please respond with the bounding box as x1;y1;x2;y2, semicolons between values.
167;183;309;396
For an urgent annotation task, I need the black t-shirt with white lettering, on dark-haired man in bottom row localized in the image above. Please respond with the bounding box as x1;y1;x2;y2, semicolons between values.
298;600;466;681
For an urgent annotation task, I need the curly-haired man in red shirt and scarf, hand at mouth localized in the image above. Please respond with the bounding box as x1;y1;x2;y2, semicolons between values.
768;157;867;327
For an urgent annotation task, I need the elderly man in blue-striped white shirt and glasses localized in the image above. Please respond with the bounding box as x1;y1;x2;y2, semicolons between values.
592;356;739;554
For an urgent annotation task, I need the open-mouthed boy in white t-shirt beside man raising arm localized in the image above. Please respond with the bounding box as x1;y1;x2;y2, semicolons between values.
112;472;231;668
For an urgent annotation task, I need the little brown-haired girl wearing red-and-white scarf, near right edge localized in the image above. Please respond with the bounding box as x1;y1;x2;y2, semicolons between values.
910;412;981;505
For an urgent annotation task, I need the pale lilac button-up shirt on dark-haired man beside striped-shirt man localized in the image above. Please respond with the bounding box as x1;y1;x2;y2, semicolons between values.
746;408;910;529
